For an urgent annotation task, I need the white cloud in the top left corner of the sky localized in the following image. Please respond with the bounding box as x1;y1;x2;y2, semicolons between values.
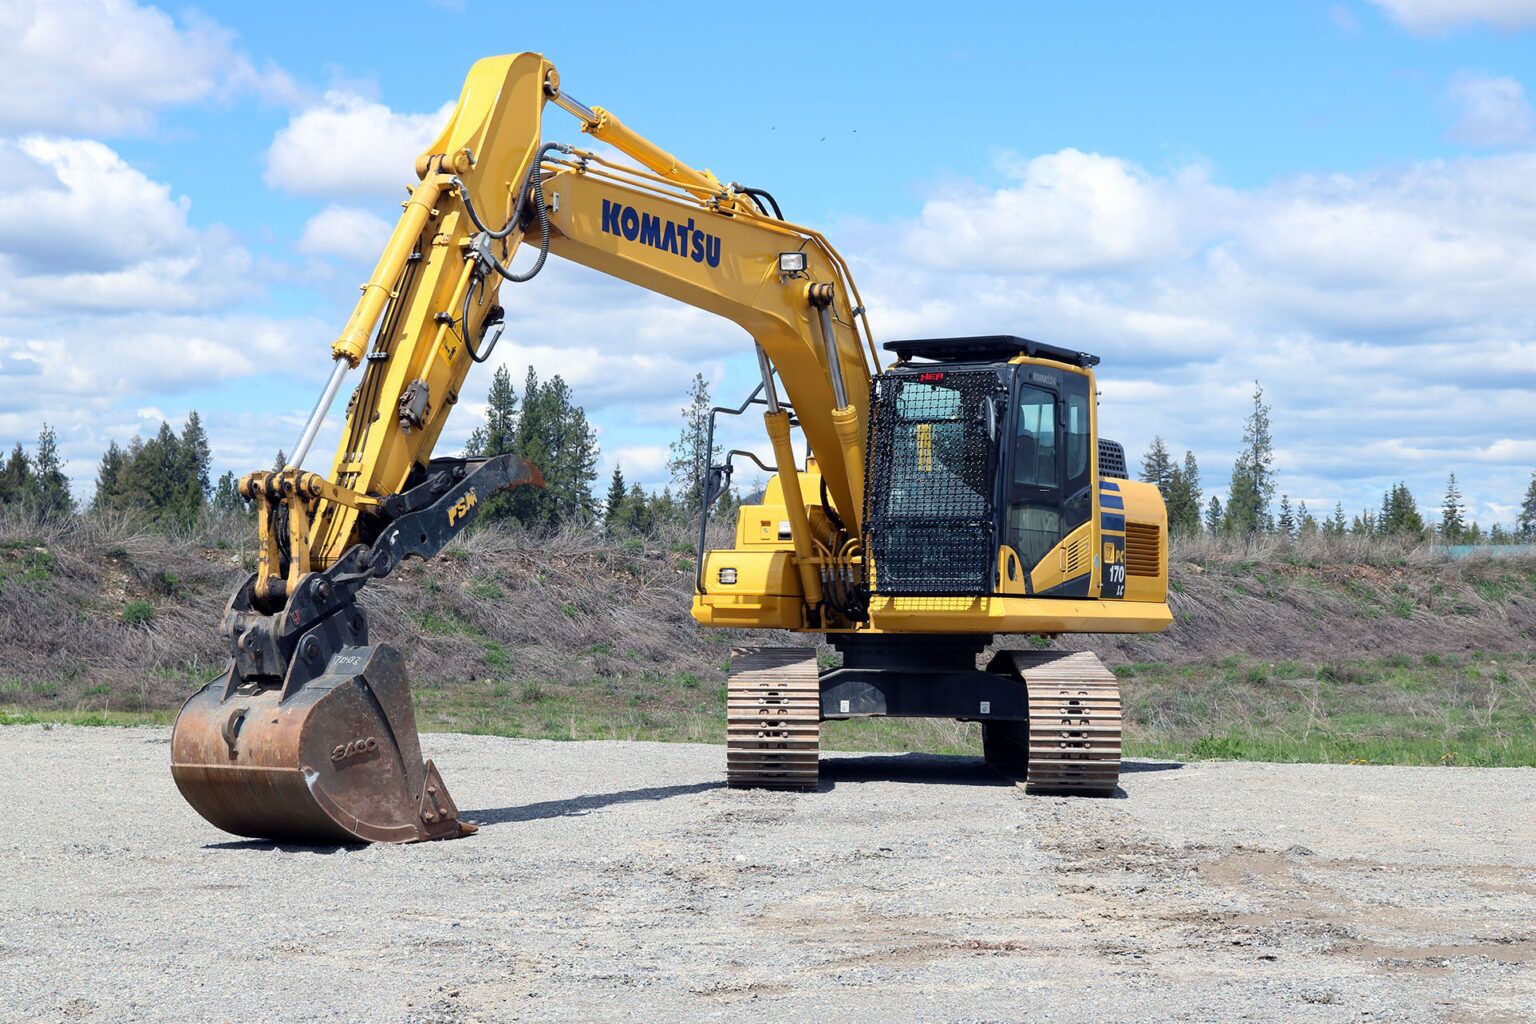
0;0;296;134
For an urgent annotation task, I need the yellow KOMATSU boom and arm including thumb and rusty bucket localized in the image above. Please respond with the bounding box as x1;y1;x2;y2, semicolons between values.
172;54;879;841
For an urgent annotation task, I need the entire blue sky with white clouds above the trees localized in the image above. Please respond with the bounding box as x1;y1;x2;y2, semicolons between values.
0;0;1536;525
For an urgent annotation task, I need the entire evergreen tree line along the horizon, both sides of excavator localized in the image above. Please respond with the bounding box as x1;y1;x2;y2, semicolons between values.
14;367;1536;543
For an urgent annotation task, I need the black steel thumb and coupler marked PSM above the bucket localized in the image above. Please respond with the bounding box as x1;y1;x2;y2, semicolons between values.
224;454;544;700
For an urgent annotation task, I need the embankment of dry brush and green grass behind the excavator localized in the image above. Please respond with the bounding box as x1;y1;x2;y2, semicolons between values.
0;524;1536;765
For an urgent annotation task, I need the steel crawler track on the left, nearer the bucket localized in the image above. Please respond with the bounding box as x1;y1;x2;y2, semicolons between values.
725;648;822;789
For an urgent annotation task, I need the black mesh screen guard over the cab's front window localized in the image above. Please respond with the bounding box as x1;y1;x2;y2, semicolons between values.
865;370;1008;596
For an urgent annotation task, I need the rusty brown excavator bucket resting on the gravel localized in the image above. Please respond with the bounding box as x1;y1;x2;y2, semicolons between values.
170;645;475;843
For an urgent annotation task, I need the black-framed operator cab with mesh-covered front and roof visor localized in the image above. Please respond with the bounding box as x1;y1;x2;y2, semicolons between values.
868;335;1124;597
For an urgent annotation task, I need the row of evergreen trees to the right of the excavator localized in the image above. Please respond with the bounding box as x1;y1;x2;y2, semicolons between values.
1140;381;1536;543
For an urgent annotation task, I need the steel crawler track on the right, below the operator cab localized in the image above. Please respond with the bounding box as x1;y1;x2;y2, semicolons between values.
986;651;1121;795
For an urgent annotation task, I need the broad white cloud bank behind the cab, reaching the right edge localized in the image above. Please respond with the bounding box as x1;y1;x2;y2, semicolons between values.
860;150;1536;521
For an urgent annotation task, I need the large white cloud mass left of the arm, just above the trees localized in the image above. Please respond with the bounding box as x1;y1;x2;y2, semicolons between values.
0;135;333;494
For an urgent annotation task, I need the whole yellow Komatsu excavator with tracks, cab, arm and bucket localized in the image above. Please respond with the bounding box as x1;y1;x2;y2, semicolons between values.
170;54;1172;843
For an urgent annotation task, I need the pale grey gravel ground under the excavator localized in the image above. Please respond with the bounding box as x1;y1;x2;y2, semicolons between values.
0;726;1536;1024
